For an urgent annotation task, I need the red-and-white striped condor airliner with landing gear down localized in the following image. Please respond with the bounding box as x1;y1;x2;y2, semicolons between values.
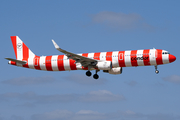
5;36;176;79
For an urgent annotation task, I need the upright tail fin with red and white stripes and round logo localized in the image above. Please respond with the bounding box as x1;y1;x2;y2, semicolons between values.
11;36;35;60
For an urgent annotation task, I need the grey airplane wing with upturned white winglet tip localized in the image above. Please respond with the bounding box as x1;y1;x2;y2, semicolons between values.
52;40;98;67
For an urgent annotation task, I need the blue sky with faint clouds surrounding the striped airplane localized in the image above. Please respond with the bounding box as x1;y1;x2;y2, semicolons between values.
0;0;180;120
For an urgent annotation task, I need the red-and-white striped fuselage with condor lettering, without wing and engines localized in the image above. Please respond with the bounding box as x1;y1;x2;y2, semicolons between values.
9;49;175;71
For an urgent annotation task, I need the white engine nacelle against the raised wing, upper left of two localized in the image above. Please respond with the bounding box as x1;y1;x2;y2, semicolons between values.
96;61;112;70
